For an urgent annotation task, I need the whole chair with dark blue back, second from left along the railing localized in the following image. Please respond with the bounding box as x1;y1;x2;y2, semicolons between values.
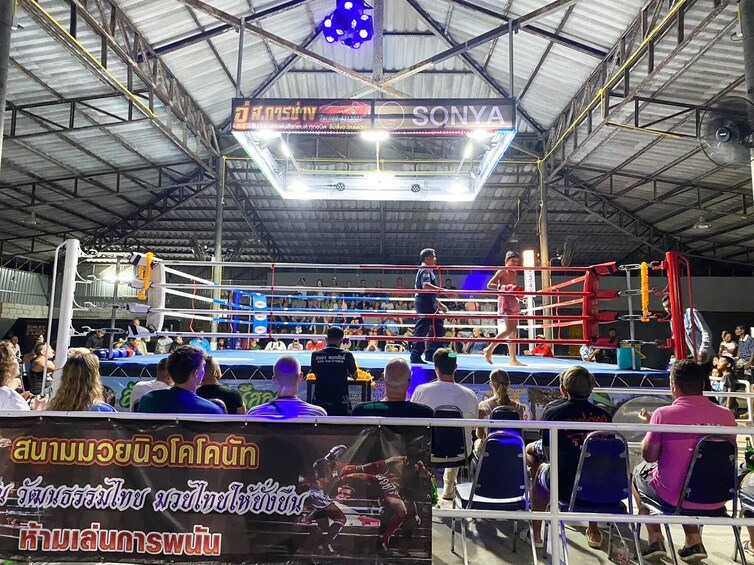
450;431;537;565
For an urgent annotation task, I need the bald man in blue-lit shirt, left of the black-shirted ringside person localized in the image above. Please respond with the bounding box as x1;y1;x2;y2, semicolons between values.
247;355;327;418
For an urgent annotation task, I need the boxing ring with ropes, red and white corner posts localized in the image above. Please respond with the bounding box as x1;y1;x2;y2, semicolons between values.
42;240;704;408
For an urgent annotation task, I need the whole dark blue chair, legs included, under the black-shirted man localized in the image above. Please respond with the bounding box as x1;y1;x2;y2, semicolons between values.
544;432;644;565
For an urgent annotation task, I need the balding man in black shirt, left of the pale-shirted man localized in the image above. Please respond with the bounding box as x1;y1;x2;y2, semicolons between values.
352;357;433;418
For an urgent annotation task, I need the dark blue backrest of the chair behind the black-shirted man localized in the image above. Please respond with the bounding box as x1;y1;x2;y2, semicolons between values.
569;432;631;511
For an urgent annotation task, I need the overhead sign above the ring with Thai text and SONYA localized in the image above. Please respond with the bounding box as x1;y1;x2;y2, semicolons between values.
233;98;516;135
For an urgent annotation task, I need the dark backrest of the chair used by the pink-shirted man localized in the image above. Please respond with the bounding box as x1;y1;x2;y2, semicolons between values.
676;435;738;513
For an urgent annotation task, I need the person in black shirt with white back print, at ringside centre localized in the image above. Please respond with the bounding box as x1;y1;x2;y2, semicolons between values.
311;327;356;416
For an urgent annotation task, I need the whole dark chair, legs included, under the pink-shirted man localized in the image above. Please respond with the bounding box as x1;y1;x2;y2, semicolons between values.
642;435;746;565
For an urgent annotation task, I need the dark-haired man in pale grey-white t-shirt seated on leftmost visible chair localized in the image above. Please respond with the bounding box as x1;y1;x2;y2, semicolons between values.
411;347;479;500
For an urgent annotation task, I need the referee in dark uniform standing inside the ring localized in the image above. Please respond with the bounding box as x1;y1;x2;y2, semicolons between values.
411;249;448;363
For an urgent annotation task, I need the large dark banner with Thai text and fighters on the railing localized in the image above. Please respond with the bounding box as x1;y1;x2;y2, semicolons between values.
0;416;432;563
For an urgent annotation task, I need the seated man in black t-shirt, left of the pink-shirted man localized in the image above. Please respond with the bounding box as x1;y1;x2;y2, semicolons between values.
523;365;611;548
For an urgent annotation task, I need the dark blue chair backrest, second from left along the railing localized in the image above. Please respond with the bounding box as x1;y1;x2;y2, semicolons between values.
468;431;529;508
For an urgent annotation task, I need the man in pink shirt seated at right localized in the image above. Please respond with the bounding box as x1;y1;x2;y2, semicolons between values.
633;360;736;562
